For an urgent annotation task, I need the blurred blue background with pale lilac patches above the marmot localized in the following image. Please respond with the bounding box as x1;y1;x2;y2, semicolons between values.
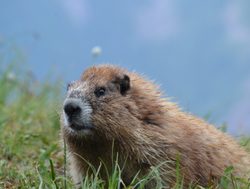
0;0;250;136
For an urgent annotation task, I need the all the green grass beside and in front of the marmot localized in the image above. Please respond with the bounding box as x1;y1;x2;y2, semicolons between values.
0;66;250;189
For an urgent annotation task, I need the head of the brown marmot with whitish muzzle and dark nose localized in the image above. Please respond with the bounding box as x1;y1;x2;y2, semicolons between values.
63;65;165;138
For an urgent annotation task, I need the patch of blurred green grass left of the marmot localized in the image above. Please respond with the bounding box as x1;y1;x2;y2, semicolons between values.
0;65;63;188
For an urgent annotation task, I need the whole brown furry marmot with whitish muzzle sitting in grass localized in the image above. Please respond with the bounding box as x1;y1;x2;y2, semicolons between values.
62;65;250;188
